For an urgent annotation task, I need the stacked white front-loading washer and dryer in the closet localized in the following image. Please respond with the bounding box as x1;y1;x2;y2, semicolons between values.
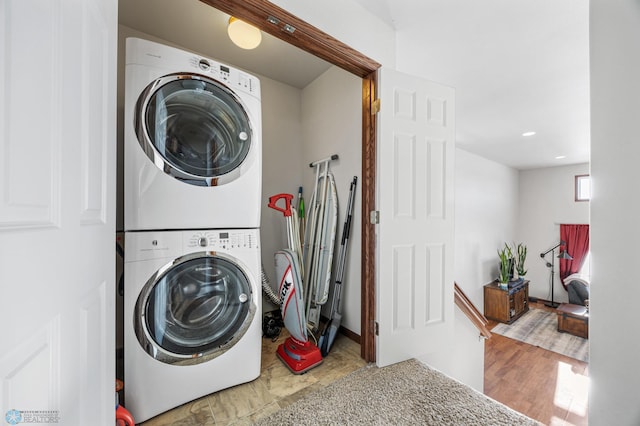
124;38;262;422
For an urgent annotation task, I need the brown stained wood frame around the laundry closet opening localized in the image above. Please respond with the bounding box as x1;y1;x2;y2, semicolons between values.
200;0;381;362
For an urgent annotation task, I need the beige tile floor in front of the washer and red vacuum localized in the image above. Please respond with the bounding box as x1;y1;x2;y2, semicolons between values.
136;331;366;426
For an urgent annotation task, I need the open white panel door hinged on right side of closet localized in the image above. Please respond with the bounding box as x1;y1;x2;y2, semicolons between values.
376;69;455;366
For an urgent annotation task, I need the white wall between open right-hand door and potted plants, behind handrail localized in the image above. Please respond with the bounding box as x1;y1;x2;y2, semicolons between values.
451;149;518;392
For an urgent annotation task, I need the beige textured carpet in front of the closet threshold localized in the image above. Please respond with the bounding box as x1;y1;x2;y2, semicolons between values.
256;359;539;426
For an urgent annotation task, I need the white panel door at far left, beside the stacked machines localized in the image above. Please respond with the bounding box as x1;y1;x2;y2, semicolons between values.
0;0;117;425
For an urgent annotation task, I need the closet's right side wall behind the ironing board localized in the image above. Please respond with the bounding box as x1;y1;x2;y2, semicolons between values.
298;67;362;334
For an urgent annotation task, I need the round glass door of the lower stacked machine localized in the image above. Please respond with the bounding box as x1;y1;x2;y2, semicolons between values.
134;252;256;364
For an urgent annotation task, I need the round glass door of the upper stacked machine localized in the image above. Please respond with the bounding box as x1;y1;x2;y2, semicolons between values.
134;73;252;186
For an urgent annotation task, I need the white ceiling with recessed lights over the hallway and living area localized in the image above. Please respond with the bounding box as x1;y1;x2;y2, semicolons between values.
355;0;590;169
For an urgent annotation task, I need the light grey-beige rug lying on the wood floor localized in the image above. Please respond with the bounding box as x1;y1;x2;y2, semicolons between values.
491;309;589;362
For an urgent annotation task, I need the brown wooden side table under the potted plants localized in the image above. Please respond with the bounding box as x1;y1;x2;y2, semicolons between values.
484;280;529;324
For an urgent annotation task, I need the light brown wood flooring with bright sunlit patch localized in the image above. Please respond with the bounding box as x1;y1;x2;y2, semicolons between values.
484;303;589;426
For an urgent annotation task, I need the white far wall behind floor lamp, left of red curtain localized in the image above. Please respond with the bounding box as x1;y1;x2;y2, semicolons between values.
515;164;589;302
